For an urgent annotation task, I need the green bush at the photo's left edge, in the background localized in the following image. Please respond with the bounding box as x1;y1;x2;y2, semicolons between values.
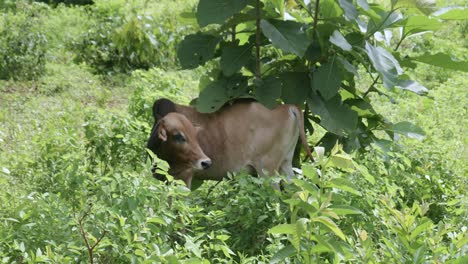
0;4;47;80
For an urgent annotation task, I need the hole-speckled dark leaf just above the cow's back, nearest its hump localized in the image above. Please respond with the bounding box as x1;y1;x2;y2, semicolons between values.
196;75;247;113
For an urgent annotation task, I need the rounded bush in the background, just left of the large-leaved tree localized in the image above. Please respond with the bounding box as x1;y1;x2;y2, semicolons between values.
74;1;195;73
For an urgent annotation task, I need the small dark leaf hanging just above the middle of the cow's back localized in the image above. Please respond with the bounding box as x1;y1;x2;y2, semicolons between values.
255;75;282;108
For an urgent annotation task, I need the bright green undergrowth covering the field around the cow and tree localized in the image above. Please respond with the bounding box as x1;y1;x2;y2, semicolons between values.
0;0;468;263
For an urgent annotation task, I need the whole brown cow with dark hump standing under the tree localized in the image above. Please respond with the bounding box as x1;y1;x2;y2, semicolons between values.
147;99;313;188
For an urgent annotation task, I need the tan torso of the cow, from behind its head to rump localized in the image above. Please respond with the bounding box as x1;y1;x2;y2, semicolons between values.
191;101;298;180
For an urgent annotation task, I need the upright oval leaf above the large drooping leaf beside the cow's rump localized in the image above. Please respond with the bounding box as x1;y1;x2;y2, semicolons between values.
312;58;343;100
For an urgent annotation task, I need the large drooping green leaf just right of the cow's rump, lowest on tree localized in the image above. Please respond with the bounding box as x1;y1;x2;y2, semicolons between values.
307;94;358;136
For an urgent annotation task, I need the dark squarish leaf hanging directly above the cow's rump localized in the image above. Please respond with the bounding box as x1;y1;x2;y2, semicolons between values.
279;72;310;105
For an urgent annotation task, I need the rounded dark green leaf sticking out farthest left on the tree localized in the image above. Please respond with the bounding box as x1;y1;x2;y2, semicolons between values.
177;33;219;69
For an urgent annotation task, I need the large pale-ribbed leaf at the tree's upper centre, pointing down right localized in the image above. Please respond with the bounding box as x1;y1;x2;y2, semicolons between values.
260;19;311;57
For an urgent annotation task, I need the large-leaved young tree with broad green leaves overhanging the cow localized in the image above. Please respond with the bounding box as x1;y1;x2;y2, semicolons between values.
178;0;468;151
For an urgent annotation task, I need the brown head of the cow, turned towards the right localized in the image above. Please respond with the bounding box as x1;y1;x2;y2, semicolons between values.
147;112;211;187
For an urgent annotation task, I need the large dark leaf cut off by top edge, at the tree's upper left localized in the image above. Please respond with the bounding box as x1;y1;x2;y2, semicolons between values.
197;0;248;27
